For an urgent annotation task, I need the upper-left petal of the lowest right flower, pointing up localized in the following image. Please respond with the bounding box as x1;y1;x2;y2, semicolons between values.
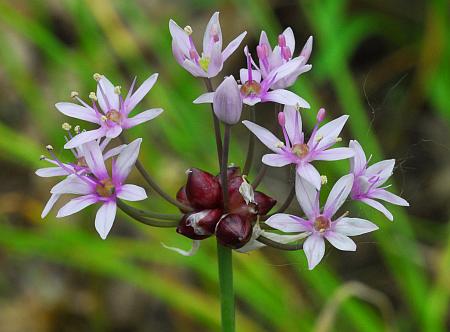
295;174;320;220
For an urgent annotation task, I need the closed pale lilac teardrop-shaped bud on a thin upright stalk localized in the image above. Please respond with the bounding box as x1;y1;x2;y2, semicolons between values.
213;76;242;125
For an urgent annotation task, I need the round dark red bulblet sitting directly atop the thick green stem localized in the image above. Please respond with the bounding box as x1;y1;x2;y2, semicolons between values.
216;214;252;249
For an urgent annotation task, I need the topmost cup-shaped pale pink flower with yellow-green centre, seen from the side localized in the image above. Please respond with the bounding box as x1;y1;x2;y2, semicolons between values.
169;12;247;78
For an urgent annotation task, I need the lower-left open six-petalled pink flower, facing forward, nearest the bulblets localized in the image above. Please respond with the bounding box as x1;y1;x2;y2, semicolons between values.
44;138;147;239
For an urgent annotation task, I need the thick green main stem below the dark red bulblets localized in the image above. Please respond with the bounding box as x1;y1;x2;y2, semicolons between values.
217;242;235;332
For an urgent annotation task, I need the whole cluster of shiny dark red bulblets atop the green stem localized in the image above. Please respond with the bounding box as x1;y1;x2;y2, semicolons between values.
177;166;276;249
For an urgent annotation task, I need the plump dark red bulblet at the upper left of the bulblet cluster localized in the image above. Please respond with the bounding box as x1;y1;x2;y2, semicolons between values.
186;168;222;209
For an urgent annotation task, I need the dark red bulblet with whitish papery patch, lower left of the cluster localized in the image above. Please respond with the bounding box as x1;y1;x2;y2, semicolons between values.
177;209;222;240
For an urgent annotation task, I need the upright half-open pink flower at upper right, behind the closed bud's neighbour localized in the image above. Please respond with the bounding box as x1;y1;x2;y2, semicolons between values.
256;28;313;89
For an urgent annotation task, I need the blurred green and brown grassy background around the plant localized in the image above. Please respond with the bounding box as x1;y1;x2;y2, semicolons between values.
0;0;450;332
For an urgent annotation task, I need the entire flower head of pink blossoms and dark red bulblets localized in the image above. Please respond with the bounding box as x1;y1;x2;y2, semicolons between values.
36;13;408;269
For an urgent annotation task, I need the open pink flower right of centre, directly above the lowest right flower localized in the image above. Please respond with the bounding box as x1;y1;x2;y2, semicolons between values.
242;107;354;189
